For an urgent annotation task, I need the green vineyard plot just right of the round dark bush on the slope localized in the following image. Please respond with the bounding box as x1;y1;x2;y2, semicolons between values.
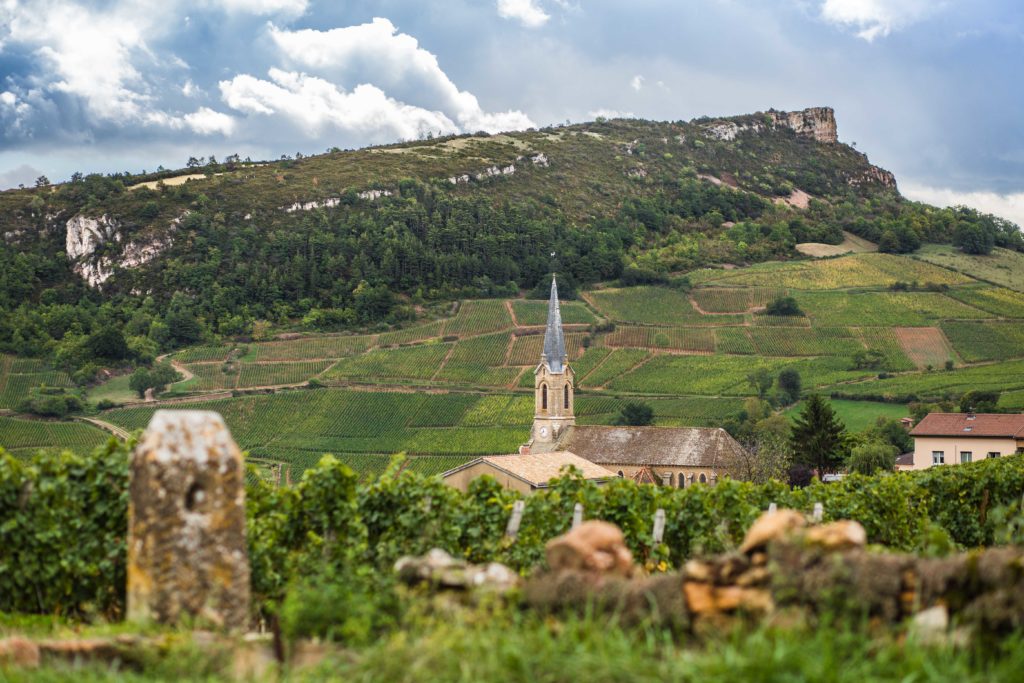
796;292;992;328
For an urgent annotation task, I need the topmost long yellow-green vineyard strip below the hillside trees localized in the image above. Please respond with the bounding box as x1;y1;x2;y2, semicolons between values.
690;254;973;290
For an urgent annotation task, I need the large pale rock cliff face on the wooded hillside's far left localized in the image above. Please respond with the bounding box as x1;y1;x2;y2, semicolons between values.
65;214;172;288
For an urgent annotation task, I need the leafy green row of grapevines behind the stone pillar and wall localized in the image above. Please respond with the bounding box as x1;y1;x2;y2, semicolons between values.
0;441;1024;615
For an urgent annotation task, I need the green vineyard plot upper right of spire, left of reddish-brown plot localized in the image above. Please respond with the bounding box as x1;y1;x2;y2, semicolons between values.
586;287;743;326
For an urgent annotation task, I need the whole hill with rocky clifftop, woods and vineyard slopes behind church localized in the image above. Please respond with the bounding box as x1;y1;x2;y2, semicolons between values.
0;109;1024;478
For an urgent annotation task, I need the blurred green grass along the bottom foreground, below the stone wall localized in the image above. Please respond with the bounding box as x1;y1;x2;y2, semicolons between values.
8;610;1024;683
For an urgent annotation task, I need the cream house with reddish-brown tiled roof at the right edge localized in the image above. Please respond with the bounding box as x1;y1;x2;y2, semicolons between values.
899;413;1024;470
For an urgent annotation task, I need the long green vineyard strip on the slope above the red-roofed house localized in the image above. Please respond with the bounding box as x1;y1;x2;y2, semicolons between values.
842;360;1024;400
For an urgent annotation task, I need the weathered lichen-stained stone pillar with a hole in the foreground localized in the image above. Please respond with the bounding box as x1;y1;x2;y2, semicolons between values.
128;411;250;628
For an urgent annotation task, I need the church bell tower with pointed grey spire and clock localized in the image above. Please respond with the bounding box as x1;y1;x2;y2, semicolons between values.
532;275;575;450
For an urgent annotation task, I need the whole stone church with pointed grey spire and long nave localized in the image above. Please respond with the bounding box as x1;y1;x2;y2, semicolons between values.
442;278;743;493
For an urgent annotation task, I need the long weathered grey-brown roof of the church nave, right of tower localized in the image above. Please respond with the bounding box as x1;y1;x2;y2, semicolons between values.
558;426;743;469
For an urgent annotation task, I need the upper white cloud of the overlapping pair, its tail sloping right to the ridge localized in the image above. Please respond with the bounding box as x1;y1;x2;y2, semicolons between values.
264;17;534;132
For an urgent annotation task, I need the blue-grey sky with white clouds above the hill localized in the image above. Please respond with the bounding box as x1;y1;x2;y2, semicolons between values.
0;0;1024;225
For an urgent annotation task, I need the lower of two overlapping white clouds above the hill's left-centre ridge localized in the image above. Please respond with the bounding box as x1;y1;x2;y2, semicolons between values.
220;69;459;139
